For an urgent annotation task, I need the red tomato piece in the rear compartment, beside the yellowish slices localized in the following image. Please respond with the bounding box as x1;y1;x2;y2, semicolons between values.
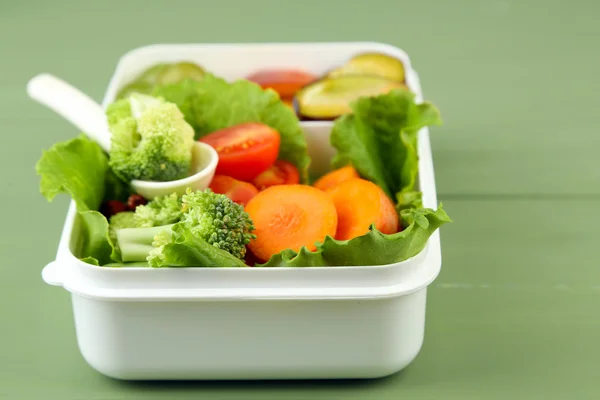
246;69;317;98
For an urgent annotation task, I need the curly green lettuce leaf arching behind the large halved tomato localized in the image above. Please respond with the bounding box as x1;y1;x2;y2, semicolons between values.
153;73;310;183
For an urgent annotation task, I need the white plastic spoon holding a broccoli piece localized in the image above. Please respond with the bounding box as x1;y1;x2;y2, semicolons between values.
27;74;219;200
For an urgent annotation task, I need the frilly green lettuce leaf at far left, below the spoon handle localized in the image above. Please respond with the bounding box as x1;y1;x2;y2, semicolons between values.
35;134;127;265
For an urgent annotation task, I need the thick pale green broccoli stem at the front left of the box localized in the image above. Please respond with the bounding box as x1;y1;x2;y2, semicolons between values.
116;224;173;262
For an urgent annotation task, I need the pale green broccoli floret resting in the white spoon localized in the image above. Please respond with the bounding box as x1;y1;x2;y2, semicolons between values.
106;93;194;181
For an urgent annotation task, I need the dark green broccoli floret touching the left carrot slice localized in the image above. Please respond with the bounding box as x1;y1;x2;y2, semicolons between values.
181;189;256;259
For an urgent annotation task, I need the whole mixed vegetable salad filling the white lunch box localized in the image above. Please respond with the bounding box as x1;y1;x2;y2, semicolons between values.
36;54;451;268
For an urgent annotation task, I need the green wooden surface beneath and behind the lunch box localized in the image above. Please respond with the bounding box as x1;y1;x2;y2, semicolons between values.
0;0;600;400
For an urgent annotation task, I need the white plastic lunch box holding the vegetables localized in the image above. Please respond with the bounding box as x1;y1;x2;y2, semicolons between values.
42;43;441;380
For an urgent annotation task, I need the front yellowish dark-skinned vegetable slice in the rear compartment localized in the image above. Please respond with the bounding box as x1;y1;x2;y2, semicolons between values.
295;75;405;120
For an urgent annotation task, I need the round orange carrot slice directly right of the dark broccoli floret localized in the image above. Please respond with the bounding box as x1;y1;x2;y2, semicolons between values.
245;185;337;261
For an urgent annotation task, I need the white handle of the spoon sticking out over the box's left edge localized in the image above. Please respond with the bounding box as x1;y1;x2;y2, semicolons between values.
27;74;110;152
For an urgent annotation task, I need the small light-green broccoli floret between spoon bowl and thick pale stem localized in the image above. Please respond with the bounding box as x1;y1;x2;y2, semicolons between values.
134;193;183;228
